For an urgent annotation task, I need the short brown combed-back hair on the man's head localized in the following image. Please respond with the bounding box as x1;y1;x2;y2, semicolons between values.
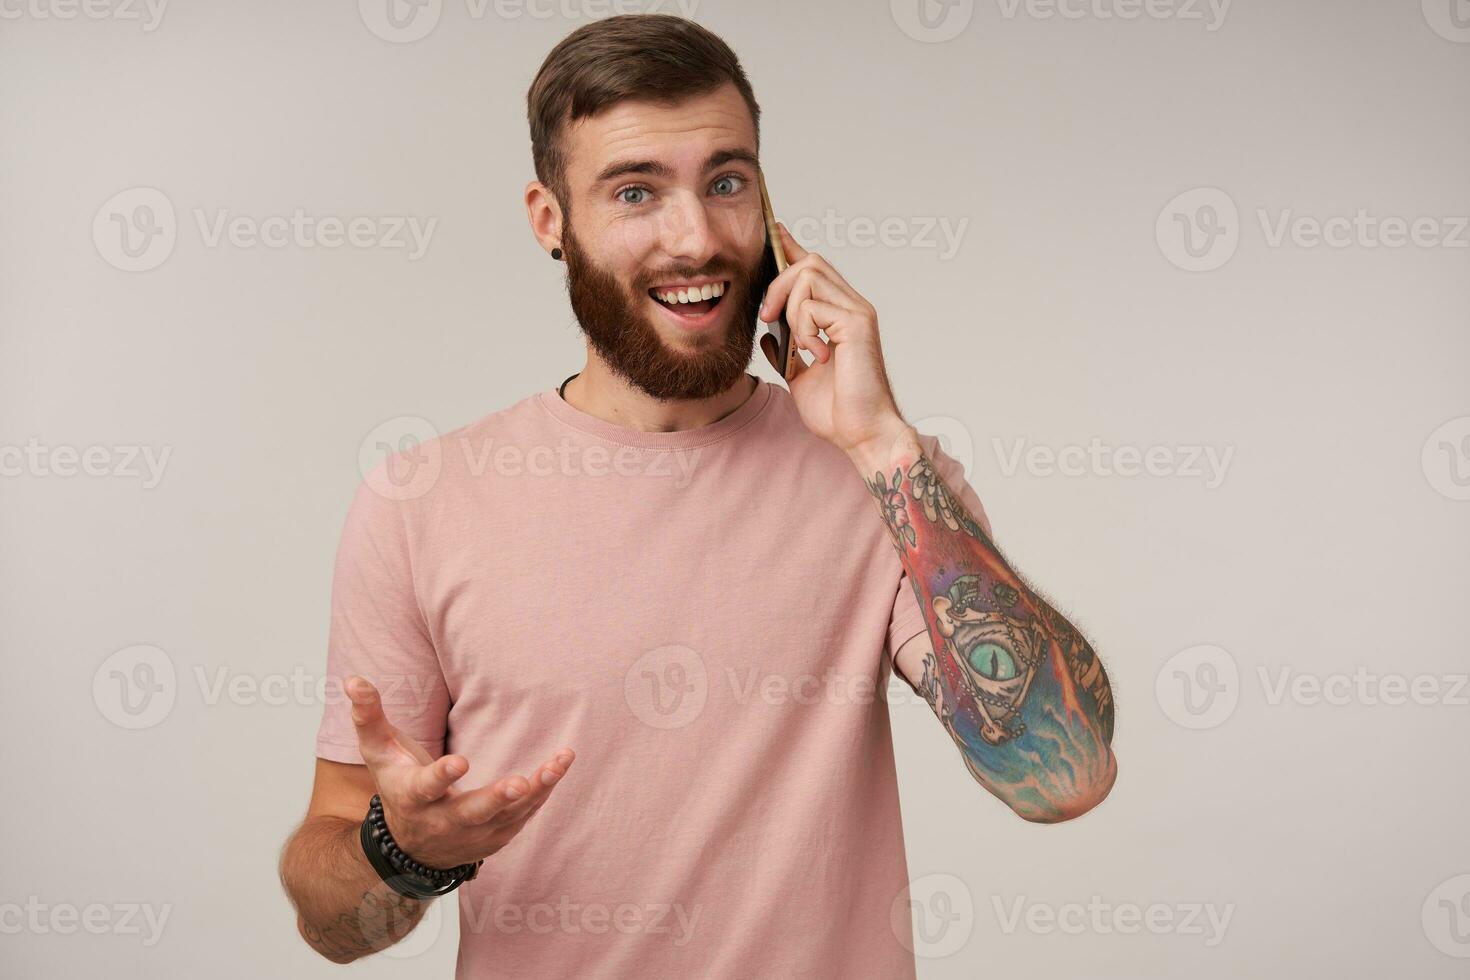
526;13;760;210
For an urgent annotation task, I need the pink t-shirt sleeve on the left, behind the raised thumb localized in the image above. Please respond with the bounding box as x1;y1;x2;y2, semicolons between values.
316;479;450;765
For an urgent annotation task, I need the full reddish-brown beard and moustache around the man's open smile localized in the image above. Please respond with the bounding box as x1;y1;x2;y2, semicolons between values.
562;220;761;401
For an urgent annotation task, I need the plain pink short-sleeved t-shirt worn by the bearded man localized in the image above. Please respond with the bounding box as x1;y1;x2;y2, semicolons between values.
316;373;989;980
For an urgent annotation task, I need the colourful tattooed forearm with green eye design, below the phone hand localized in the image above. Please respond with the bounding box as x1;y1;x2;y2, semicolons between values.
850;426;1117;823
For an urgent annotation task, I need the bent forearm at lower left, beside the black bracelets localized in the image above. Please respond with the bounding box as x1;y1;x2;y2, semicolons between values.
281;815;428;962
